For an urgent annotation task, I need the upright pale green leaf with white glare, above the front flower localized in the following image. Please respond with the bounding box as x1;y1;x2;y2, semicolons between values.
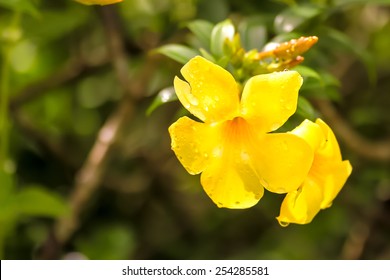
210;19;235;59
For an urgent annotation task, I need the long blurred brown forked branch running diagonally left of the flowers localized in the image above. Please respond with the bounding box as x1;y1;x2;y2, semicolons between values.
55;6;154;243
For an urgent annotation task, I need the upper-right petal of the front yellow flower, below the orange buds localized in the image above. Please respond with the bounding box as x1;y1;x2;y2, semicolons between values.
241;71;302;132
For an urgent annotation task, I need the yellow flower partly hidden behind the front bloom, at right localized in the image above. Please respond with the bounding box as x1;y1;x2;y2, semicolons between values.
277;119;352;226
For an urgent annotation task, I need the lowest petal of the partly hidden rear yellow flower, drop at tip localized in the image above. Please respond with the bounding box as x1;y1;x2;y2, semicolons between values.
276;179;323;226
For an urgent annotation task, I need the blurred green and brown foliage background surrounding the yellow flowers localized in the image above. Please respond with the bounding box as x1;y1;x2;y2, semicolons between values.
0;0;390;259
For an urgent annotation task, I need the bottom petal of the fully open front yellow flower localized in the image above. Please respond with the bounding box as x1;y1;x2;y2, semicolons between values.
201;154;264;209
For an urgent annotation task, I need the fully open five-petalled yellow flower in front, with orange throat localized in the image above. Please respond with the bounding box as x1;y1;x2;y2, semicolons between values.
169;56;313;208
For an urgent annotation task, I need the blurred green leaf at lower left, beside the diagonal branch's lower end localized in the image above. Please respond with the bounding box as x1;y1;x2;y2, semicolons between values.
14;186;68;217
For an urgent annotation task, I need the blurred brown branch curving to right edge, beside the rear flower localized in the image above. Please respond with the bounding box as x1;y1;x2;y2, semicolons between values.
313;99;390;161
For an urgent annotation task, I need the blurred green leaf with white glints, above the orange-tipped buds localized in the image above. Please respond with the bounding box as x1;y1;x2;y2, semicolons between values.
274;5;322;33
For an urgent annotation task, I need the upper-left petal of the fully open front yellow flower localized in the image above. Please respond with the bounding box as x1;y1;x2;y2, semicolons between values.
174;56;239;123
